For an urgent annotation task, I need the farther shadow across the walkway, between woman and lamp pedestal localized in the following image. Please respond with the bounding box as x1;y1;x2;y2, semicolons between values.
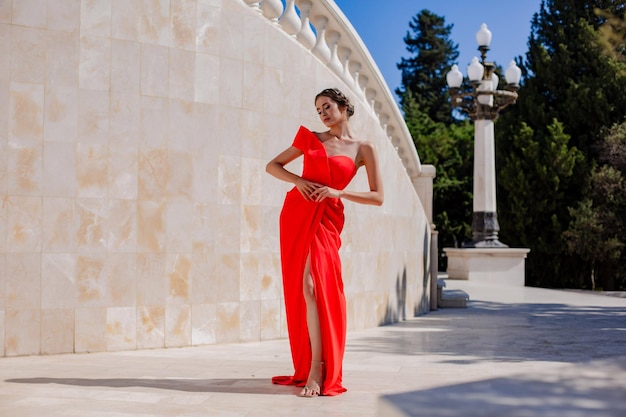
347;301;626;364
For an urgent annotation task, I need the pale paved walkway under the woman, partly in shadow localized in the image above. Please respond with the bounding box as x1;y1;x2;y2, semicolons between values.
0;280;626;417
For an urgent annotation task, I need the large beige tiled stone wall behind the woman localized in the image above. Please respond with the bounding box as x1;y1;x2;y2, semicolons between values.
0;0;429;356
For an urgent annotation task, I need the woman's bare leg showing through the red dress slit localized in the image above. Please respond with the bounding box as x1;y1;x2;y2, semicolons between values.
300;257;323;397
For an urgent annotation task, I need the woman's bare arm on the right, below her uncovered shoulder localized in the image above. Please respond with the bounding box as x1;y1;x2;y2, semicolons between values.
311;142;385;206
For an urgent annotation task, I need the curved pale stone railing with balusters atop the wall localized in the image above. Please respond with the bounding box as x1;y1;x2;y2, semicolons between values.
244;0;422;185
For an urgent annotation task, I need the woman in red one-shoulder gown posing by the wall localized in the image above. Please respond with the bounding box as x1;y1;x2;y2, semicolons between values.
266;88;383;397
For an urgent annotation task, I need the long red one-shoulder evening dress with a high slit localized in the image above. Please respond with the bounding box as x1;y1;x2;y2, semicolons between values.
272;126;356;395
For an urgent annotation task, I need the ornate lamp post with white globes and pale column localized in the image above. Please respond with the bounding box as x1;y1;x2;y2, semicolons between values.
446;23;522;248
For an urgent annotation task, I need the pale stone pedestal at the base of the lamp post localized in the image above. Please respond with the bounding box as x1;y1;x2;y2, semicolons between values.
443;248;530;287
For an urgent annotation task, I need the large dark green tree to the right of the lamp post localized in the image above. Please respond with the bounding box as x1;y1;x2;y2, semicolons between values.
496;0;626;287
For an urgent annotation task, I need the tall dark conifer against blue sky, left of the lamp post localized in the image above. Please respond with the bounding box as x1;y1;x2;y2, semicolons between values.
396;10;459;123
